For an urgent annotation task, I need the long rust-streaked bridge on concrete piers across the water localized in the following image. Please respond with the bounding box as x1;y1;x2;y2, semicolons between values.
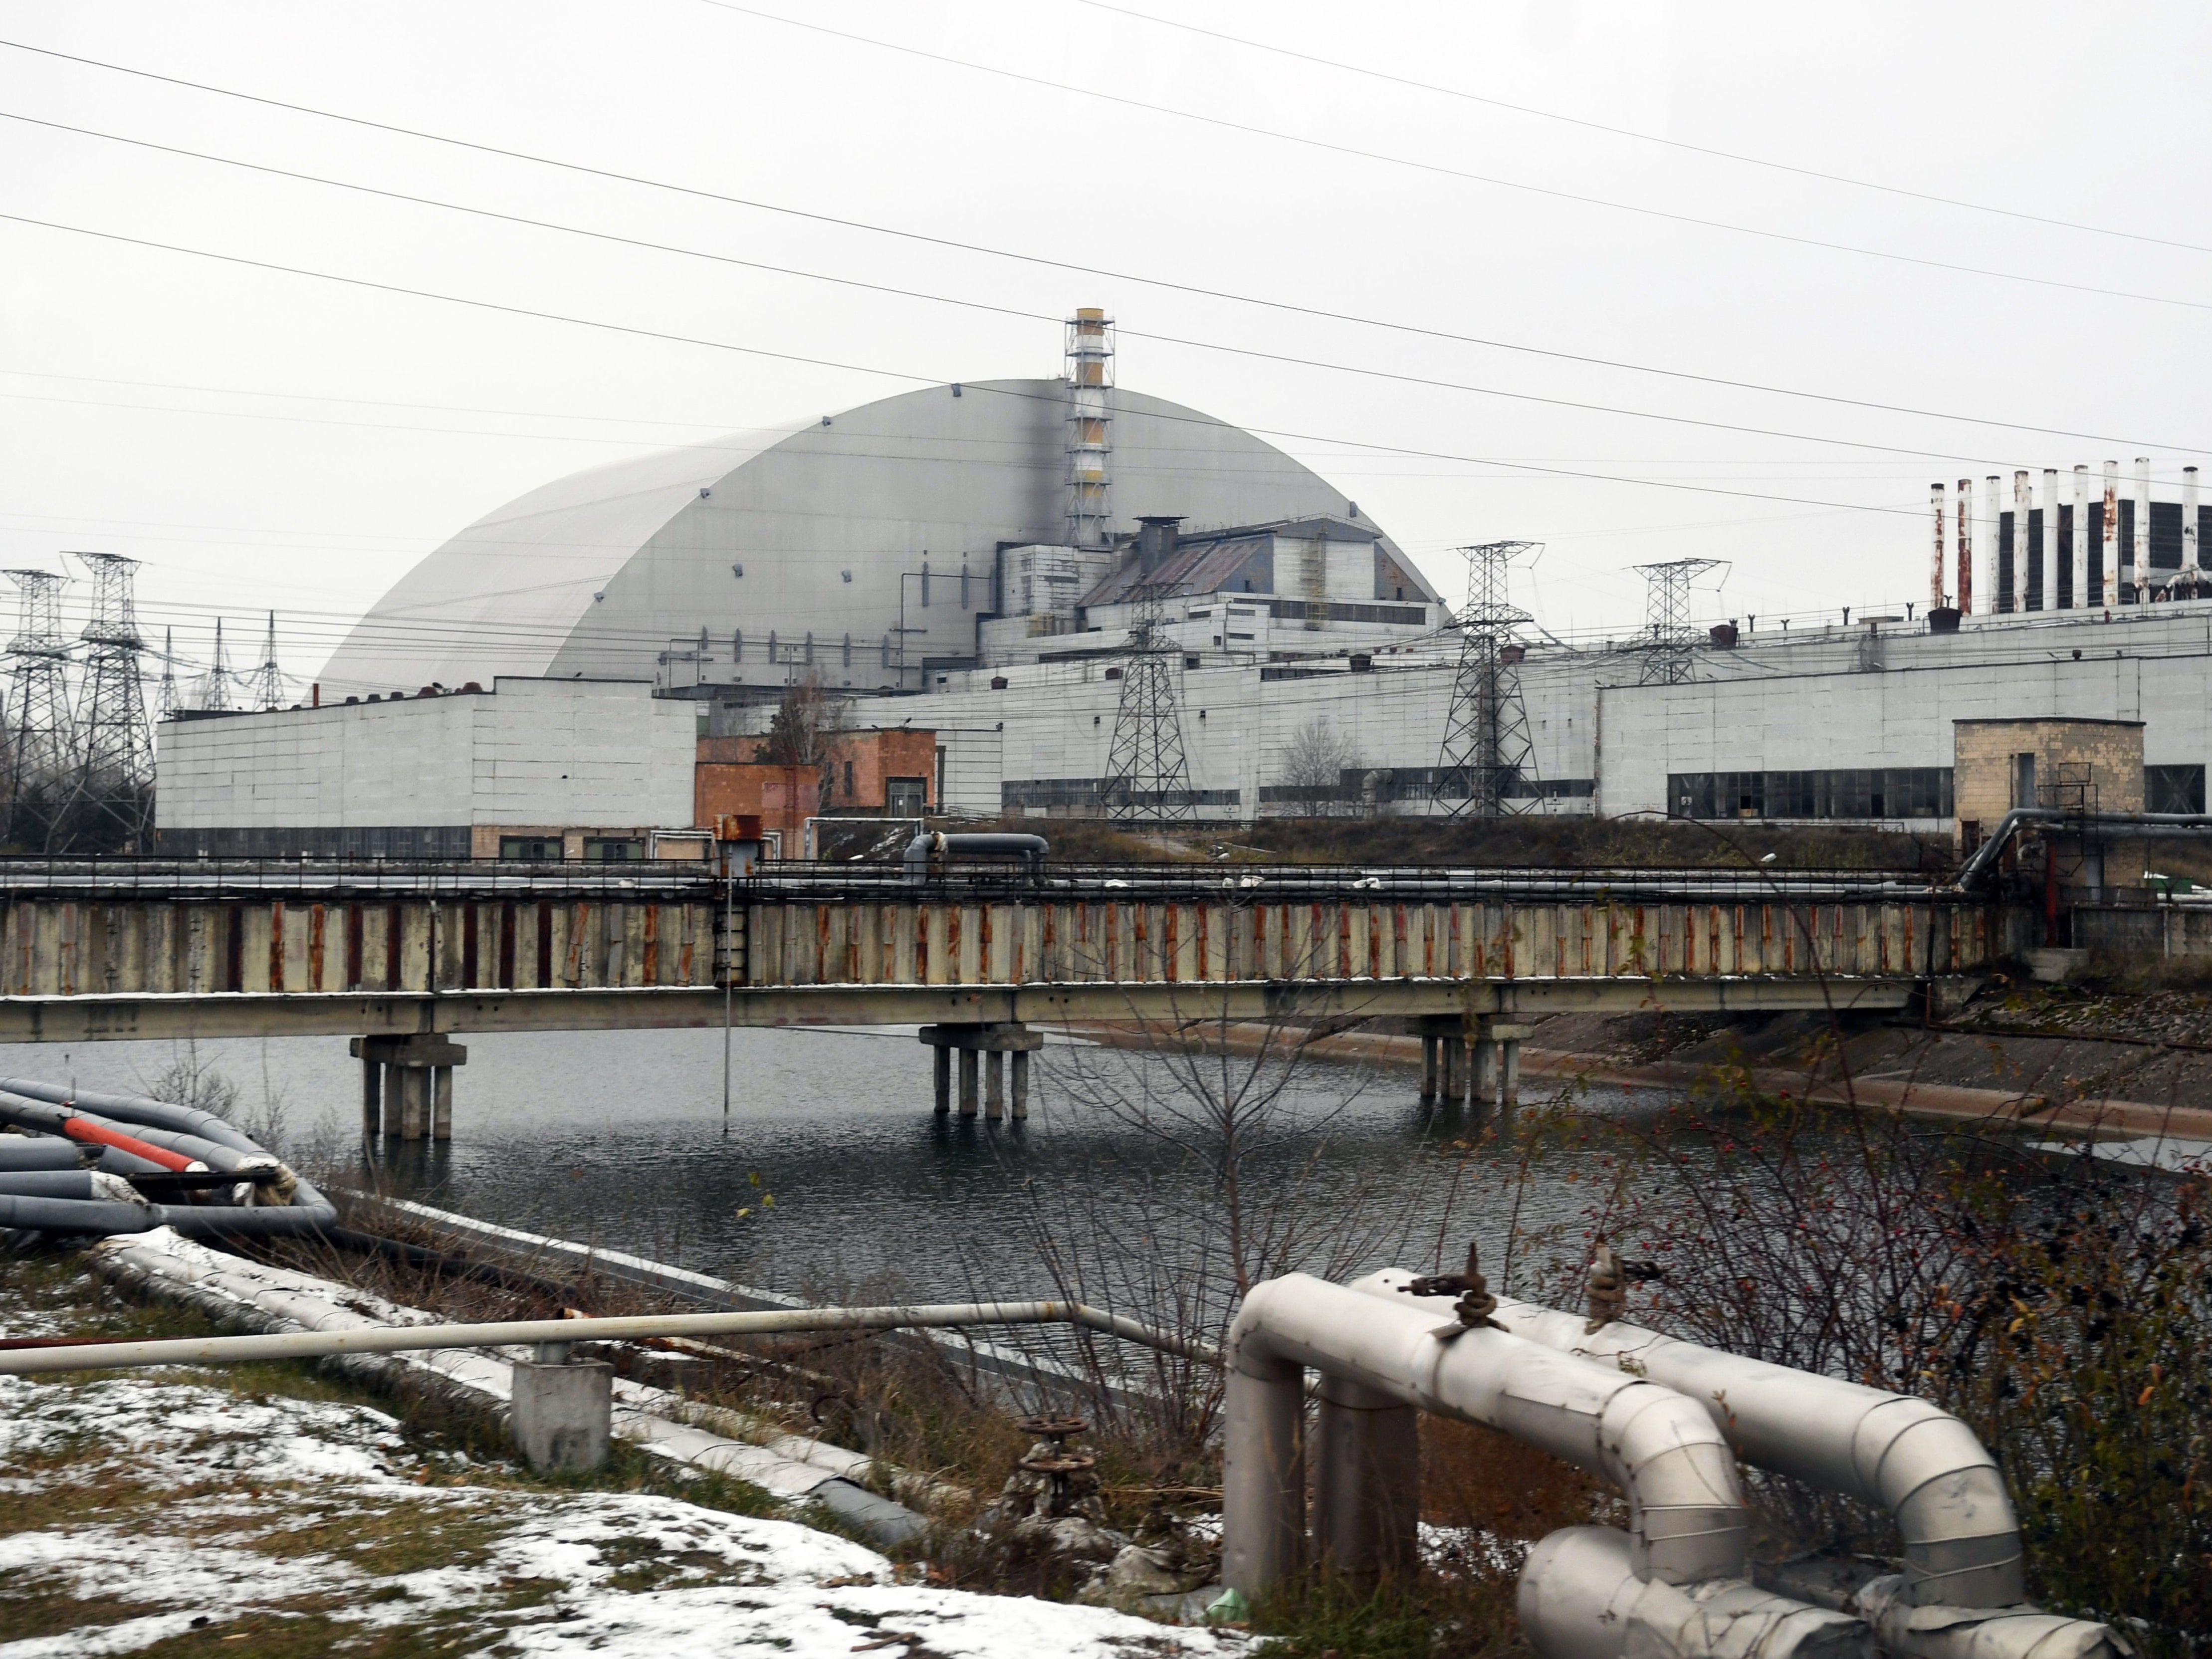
0;860;2033;1139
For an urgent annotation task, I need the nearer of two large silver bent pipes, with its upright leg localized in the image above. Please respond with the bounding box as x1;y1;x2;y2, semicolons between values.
1221;1274;1869;1659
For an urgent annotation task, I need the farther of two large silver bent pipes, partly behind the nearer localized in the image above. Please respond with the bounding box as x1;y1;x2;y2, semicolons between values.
1354;1267;2124;1659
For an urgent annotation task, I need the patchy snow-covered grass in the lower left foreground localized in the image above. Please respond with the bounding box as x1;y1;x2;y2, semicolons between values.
0;1371;1245;1659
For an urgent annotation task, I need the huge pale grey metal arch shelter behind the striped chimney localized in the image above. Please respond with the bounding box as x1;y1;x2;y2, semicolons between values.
323;381;1436;694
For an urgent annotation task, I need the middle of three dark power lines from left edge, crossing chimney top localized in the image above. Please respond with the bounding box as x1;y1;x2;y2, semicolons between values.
0;111;2159;467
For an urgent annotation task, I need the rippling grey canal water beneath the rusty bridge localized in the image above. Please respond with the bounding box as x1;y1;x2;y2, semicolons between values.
0;1029;1663;1296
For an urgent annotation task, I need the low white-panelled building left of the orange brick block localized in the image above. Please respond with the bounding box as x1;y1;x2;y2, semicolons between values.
155;677;697;858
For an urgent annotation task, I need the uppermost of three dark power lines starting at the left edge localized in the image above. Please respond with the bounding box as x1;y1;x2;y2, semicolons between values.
0;40;2201;449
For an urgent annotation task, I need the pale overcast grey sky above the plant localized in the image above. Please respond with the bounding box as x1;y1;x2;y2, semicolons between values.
0;0;2212;690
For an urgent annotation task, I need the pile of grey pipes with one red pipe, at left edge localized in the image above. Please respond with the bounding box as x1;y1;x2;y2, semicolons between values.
0;1079;338;1237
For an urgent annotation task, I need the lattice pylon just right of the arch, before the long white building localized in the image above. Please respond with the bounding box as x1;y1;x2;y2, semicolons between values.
1431;542;1538;819
